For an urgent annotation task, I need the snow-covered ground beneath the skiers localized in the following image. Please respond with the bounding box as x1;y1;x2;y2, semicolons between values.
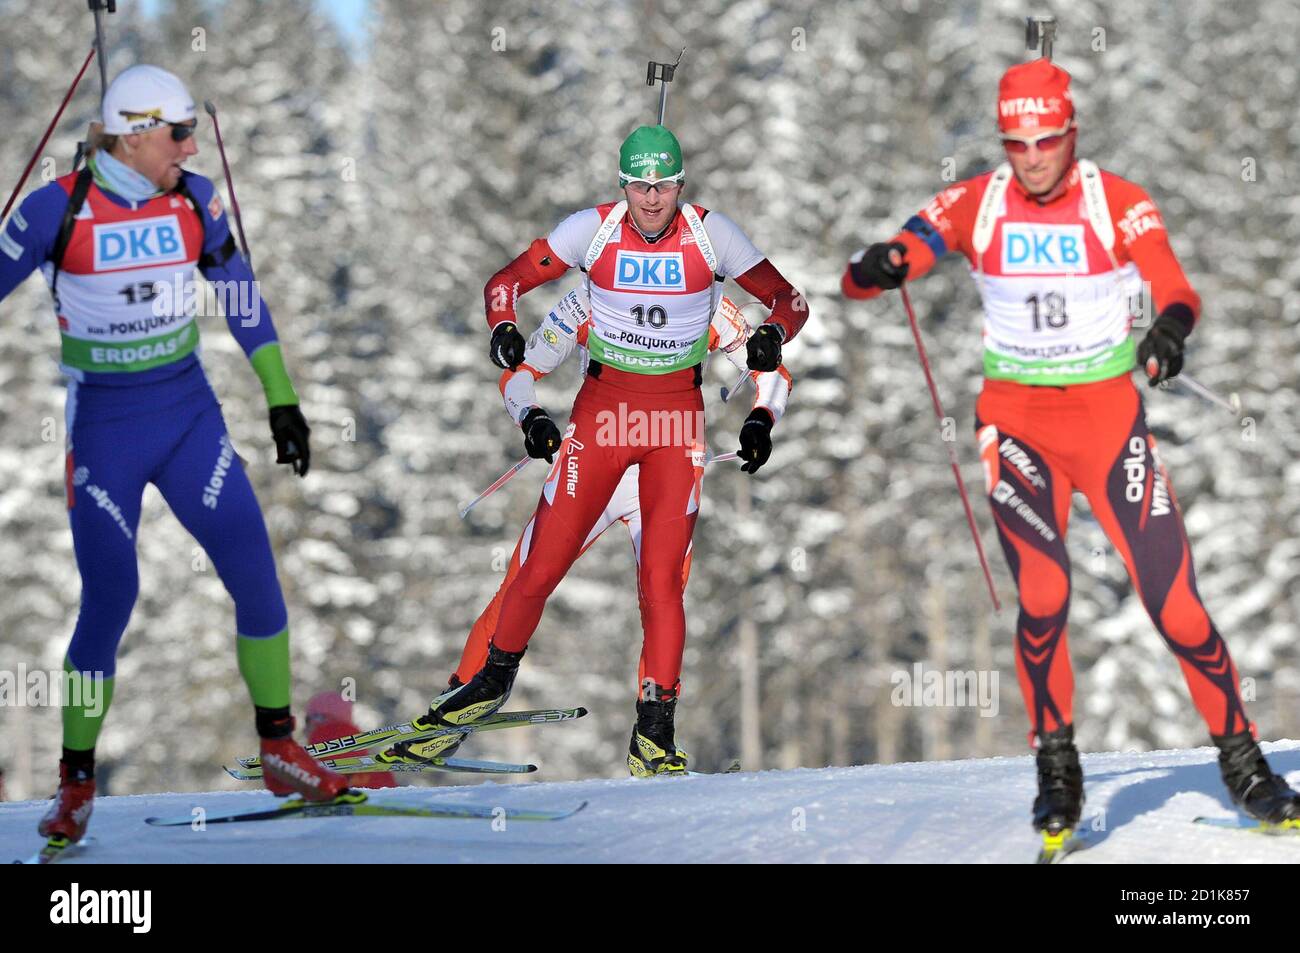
0;741;1300;863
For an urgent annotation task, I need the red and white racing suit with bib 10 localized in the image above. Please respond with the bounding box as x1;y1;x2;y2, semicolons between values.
484;202;807;697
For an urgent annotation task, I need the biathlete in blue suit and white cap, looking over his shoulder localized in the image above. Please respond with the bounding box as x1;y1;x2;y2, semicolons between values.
0;66;347;841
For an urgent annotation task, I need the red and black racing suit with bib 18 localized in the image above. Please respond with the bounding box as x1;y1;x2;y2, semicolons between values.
841;160;1253;735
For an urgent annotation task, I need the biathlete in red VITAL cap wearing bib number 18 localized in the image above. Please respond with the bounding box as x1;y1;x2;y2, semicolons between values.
842;60;1300;835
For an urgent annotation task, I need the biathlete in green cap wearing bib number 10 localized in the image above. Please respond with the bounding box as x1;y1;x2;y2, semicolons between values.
384;126;807;776
